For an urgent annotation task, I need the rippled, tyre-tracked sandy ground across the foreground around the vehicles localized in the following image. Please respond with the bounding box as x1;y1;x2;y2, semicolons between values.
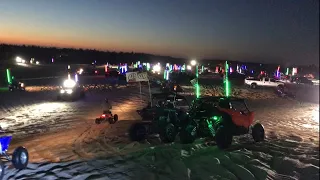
0;87;319;180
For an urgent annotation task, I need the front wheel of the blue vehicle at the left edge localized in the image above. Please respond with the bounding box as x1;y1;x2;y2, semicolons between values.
12;146;29;169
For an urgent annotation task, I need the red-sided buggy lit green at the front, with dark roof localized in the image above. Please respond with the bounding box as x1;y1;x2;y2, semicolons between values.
180;97;265;149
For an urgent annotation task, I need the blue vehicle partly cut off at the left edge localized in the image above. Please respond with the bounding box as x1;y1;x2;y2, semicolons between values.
0;136;29;180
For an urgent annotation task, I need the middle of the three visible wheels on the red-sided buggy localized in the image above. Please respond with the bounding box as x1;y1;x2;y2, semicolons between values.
215;125;232;149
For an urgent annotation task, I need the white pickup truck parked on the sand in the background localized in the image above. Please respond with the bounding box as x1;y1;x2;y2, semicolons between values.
244;77;284;89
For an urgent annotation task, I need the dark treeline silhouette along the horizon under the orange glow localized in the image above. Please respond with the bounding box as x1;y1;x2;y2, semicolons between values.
0;44;185;64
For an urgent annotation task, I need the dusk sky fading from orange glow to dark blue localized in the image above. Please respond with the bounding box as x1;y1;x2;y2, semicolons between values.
0;0;319;64
